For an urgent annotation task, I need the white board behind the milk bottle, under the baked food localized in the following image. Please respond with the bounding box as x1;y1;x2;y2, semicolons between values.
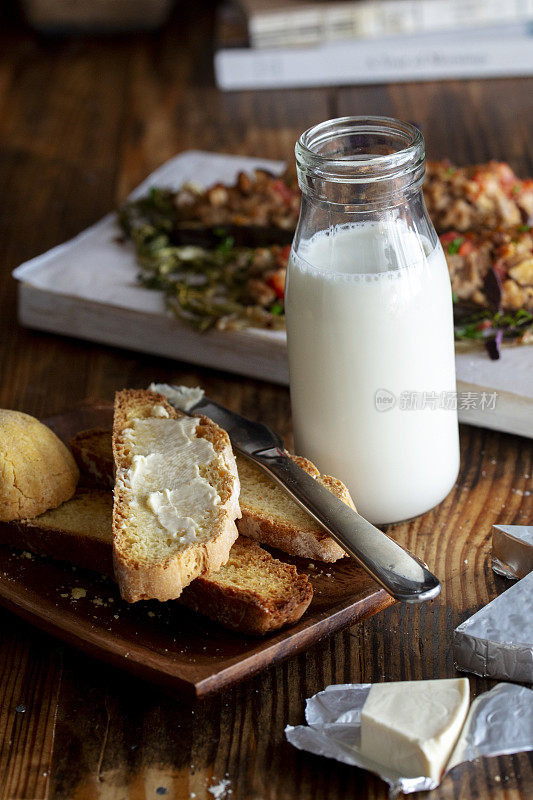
13;151;533;437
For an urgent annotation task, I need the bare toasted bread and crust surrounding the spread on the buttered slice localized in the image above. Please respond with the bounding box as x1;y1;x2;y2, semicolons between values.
113;389;240;603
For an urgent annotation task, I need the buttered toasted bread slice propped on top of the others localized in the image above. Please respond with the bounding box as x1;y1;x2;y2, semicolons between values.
113;389;240;603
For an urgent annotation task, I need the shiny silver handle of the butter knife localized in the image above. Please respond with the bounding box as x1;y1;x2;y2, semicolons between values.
248;448;441;603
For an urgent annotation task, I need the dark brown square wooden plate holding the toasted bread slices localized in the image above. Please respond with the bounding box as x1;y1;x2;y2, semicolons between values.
0;403;394;697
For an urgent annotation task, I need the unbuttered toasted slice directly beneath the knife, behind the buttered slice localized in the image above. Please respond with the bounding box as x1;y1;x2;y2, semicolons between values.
70;429;355;562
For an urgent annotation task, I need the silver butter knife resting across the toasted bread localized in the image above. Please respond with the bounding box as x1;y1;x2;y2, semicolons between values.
159;385;441;603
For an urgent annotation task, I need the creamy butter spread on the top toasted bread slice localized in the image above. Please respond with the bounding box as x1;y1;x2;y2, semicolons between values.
124;416;220;543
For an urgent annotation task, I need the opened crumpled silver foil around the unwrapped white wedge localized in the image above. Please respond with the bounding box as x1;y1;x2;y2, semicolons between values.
285;683;533;798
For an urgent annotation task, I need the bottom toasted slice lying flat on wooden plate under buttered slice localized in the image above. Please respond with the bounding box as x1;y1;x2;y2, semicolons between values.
0;489;313;635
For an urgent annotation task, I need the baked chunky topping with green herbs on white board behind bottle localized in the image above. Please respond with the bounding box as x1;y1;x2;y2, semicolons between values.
119;161;533;358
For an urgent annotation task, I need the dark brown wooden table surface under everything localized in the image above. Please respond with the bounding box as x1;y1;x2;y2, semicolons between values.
0;3;533;800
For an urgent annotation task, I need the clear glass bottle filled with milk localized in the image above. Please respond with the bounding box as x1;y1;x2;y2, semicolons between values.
286;117;459;524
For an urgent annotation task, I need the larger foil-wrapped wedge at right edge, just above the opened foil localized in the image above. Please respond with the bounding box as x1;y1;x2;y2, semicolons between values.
453;572;533;683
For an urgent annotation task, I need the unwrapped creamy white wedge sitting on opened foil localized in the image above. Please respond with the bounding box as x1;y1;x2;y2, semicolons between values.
361;678;470;782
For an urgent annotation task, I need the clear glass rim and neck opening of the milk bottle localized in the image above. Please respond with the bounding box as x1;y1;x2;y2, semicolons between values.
295;117;425;211
